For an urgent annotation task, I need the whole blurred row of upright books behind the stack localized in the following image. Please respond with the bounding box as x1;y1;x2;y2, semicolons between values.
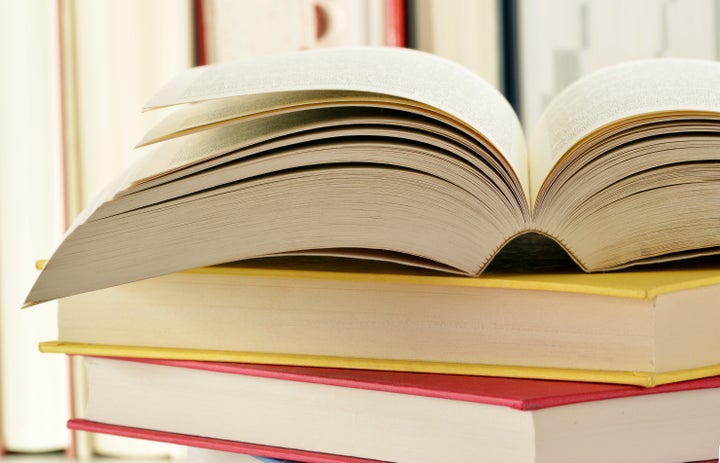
0;0;720;461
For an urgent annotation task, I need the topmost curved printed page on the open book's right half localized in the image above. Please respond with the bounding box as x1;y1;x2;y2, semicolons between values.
530;58;720;202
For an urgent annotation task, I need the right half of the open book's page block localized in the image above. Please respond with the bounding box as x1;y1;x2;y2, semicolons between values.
530;59;720;271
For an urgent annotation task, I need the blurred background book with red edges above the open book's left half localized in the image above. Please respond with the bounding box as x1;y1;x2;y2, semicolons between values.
195;0;404;64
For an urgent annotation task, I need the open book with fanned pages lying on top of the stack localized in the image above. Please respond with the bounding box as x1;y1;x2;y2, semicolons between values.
27;48;720;304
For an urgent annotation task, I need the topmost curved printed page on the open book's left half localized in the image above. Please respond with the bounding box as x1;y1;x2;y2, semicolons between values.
146;47;528;198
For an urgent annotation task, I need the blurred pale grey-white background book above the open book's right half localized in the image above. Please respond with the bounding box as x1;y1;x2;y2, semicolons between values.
517;0;720;130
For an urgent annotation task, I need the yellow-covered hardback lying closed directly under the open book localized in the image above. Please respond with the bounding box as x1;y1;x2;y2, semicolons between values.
41;265;720;386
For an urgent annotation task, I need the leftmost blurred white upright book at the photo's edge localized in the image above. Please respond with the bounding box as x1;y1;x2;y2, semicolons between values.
0;1;70;452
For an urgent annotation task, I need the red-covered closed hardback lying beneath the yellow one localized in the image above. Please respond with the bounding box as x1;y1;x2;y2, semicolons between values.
76;357;720;463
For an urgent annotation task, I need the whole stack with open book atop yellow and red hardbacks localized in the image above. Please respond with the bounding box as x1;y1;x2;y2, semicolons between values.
27;48;720;463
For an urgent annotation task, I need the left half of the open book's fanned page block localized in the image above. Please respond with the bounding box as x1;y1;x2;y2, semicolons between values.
23;47;529;304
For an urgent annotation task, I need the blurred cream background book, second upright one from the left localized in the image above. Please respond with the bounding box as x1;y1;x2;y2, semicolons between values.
57;0;194;458
